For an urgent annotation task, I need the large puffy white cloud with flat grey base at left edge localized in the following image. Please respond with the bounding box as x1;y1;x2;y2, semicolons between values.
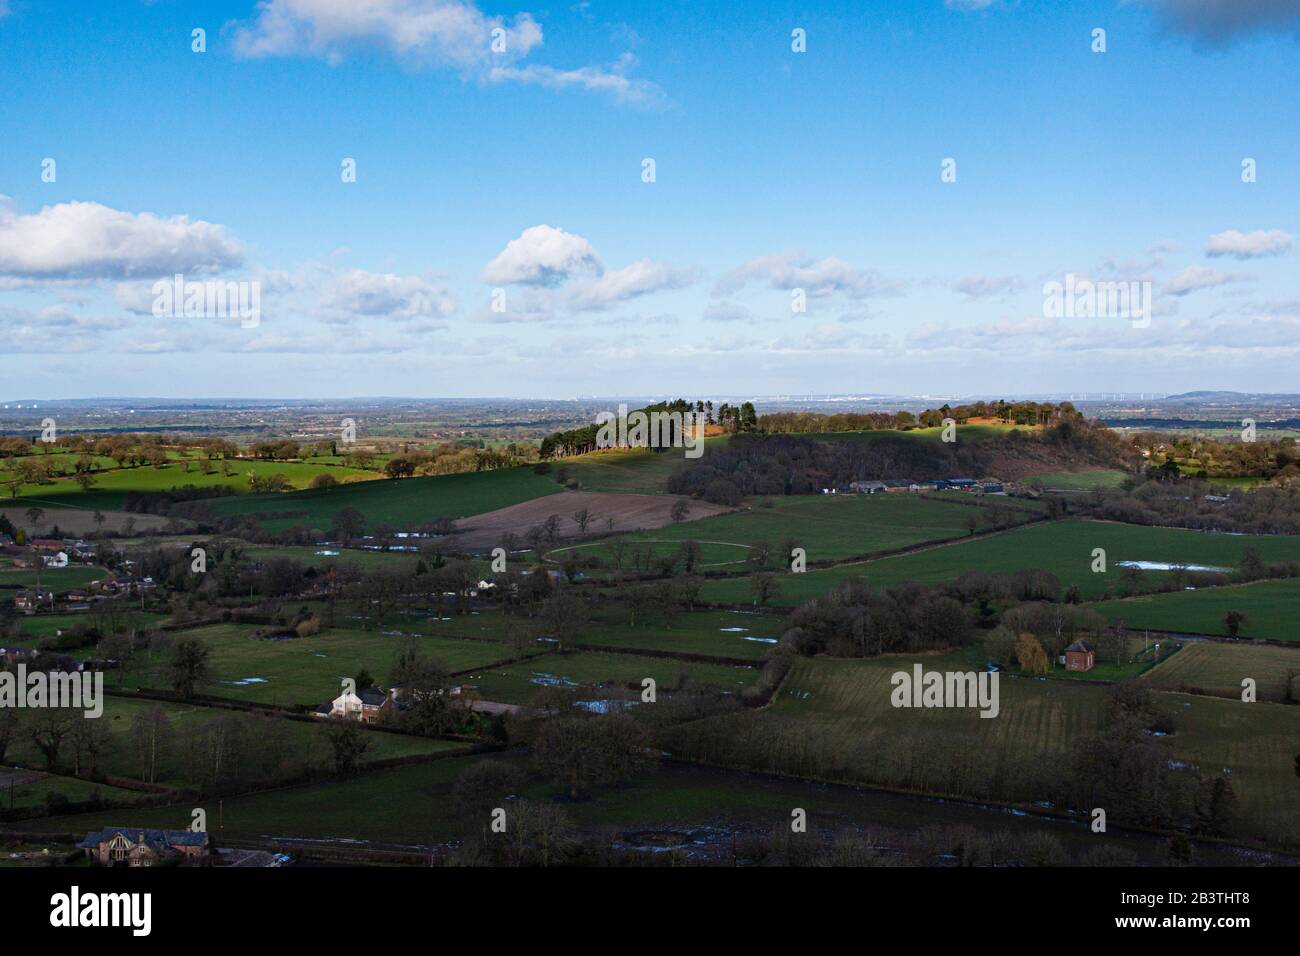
0;196;243;280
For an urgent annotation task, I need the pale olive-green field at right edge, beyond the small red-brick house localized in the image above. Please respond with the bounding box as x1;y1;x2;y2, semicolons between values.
1143;641;1300;704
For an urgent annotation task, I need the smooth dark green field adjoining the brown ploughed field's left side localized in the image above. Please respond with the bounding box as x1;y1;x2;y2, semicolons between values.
212;468;562;531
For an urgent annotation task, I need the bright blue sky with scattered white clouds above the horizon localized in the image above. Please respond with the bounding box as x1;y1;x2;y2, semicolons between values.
0;0;1300;399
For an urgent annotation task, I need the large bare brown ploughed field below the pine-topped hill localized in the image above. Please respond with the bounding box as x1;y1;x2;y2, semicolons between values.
455;492;731;551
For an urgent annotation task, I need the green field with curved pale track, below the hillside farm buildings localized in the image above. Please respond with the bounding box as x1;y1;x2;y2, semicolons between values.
553;494;1008;567
